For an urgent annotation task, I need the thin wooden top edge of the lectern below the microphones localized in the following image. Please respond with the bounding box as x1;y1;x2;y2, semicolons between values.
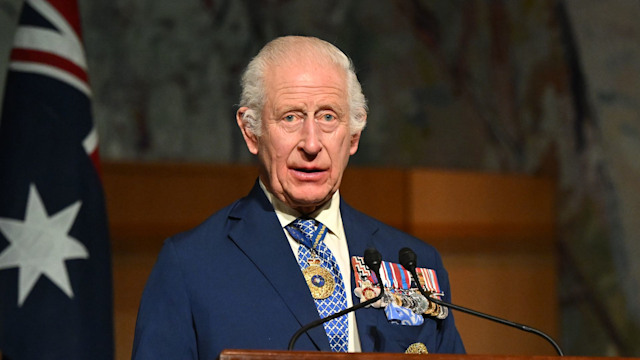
220;349;624;360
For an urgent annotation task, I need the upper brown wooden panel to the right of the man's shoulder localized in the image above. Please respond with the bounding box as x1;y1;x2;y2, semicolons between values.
407;169;555;251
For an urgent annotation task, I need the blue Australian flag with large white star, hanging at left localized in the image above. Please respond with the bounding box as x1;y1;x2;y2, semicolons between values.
0;0;114;360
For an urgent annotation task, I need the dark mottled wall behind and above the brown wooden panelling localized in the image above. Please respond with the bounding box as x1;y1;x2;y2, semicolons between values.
0;0;640;356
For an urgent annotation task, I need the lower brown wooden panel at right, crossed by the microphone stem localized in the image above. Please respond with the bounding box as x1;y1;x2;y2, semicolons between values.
443;251;559;355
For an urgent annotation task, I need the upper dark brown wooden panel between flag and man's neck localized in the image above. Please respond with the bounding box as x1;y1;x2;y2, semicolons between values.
102;162;258;251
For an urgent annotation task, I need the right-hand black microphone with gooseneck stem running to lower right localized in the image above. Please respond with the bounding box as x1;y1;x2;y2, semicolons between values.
398;248;564;356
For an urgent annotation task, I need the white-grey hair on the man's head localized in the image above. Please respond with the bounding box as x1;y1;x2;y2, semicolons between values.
239;36;367;136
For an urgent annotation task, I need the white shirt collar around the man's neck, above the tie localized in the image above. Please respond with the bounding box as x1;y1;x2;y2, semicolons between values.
259;180;340;234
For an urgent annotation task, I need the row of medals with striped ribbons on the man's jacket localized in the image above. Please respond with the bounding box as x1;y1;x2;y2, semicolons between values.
351;256;449;325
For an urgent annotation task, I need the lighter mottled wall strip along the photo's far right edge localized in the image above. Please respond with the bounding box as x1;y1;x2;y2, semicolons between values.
565;0;640;356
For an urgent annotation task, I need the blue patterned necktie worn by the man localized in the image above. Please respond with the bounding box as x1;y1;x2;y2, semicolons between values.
286;219;349;352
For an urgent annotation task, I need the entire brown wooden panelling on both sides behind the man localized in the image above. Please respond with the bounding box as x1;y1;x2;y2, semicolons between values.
103;163;558;359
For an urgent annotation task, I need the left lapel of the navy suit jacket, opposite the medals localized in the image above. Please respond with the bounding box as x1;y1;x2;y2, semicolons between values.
229;182;331;351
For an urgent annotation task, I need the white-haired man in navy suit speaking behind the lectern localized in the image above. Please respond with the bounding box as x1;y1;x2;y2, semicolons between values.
133;36;464;359
